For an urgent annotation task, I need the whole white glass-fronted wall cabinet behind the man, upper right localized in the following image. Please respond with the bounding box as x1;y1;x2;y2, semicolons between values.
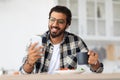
56;0;120;41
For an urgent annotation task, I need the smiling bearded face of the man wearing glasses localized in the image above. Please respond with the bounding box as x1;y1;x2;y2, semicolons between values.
48;12;67;38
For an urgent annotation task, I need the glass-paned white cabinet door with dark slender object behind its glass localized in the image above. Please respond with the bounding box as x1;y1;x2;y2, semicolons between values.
86;0;106;36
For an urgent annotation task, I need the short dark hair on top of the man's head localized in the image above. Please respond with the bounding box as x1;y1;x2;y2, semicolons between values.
49;5;72;25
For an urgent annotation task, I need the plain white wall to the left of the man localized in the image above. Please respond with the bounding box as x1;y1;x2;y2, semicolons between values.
0;0;54;70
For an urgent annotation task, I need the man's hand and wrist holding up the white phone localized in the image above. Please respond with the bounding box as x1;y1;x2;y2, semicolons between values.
23;43;44;73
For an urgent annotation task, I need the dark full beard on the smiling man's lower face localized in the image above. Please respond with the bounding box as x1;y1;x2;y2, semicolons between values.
49;26;66;38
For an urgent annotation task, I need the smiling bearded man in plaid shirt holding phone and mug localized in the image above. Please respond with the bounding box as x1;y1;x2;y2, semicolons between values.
20;6;103;73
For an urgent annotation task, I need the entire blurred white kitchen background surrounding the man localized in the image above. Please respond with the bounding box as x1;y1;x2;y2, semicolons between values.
0;0;120;74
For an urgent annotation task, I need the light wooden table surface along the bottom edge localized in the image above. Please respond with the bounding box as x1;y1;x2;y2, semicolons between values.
0;73;120;80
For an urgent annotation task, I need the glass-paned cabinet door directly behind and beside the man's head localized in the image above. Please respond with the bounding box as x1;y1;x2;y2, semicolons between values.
57;0;79;34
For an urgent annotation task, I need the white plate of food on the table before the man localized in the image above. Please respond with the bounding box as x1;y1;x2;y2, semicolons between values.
55;69;85;74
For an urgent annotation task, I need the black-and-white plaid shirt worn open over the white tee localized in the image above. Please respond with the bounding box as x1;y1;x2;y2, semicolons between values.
21;31;88;73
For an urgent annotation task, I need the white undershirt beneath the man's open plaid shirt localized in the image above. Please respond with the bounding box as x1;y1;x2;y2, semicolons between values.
48;44;60;74
